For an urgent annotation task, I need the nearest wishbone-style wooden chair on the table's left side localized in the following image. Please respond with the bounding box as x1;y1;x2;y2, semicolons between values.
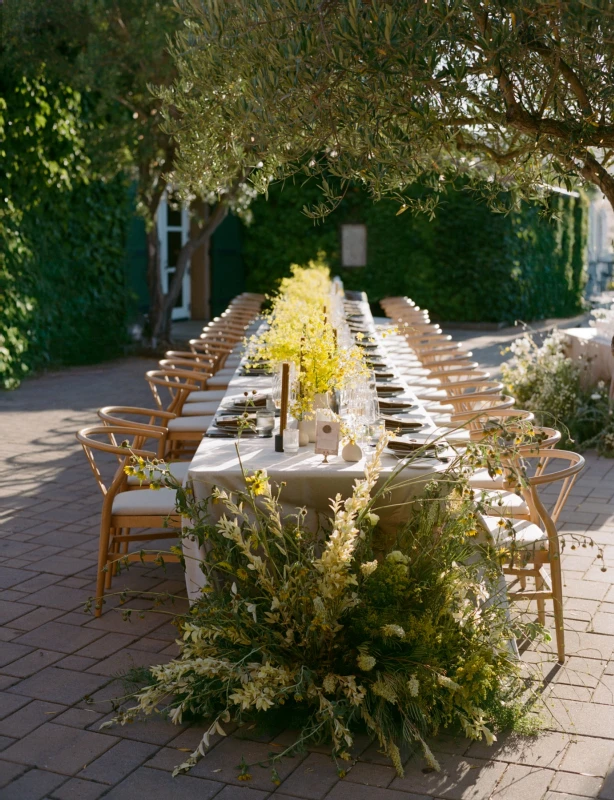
76;425;181;617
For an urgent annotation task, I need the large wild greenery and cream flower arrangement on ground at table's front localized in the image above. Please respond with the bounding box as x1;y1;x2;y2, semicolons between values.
105;437;543;782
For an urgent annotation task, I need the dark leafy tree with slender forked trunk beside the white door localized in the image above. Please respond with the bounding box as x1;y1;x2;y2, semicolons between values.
0;0;250;344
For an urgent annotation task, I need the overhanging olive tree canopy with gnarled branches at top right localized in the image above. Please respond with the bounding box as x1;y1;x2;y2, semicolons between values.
161;0;614;215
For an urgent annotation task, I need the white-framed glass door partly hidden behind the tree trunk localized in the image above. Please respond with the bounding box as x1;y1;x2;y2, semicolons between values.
158;192;190;319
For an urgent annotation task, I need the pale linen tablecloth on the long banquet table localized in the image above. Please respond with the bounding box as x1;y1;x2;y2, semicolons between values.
183;302;460;600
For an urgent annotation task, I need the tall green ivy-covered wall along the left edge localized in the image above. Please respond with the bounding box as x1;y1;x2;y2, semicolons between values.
0;70;130;388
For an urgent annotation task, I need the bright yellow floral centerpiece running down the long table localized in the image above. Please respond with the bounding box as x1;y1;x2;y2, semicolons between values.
247;261;368;419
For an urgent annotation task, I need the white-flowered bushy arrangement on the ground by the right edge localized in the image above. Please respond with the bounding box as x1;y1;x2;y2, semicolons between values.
501;330;614;457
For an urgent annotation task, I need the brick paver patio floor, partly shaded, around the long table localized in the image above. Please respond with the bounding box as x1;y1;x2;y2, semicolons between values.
0;359;614;800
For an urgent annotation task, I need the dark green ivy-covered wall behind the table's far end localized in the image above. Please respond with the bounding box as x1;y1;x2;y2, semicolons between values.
243;179;588;322
